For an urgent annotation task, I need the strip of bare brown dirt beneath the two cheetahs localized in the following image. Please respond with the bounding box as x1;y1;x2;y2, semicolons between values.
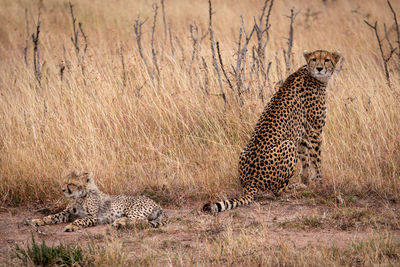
0;195;400;264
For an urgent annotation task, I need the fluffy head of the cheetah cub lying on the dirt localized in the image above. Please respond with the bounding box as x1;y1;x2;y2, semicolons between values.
62;170;97;198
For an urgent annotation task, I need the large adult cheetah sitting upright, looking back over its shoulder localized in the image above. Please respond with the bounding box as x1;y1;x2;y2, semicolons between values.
203;50;341;214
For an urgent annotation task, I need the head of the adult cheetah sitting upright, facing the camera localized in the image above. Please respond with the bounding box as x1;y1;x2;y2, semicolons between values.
304;50;342;83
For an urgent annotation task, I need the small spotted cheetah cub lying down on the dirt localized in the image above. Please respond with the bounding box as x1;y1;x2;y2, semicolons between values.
31;171;167;232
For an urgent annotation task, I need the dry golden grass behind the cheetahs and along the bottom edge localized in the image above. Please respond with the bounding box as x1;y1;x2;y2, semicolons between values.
0;0;400;266
